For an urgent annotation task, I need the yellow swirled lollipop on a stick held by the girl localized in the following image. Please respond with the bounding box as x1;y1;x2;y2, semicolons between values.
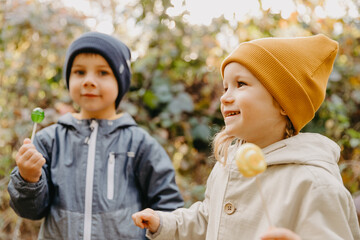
235;143;273;227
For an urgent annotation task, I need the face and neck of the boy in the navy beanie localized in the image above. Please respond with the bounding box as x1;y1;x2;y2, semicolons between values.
69;53;119;119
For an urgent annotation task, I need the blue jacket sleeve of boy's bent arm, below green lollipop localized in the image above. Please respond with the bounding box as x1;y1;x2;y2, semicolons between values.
8;132;51;220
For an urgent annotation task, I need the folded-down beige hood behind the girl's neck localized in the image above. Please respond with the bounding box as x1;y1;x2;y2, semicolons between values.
262;133;340;181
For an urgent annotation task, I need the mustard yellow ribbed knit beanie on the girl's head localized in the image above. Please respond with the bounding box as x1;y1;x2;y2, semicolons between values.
220;34;338;134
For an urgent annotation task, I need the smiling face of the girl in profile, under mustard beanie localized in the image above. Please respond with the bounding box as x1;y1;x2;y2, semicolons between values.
220;62;286;148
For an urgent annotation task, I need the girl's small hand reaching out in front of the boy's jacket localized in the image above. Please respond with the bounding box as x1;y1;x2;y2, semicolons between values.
132;208;160;233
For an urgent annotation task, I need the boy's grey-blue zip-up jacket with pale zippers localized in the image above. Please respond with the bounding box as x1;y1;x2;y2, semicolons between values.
8;113;183;240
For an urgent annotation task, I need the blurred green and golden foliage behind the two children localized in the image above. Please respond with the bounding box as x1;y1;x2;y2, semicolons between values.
0;0;360;239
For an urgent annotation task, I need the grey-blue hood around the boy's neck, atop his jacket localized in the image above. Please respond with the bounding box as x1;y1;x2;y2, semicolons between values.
58;113;137;134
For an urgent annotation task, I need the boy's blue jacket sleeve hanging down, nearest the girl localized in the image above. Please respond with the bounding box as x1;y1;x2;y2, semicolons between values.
135;134;184;211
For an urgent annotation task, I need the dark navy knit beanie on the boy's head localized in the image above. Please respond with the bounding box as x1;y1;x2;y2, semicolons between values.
63;32;131;108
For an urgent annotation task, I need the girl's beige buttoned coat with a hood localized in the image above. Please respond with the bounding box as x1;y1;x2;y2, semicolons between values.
148;133;360;240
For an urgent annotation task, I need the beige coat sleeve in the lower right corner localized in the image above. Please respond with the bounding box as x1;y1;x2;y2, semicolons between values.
295;182;360;239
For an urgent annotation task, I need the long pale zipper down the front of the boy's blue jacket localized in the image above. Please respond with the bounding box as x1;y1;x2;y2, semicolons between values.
83;120;99;240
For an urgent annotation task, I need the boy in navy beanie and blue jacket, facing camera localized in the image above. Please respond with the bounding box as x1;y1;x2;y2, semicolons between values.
8;32;183;239
